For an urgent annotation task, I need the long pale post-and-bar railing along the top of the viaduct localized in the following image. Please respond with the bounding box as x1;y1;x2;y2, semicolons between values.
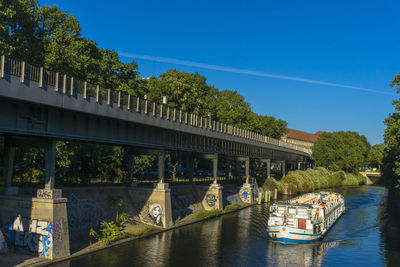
0;55;311;155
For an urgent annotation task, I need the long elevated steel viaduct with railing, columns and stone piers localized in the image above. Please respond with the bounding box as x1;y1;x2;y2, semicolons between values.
0;56;311;258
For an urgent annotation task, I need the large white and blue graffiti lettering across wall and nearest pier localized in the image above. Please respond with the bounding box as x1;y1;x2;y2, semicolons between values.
8;215;53;257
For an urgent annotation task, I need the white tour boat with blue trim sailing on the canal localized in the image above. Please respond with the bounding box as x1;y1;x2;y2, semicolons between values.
267;192;345;242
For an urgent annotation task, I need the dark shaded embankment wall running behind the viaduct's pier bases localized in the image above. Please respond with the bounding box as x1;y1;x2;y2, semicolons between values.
0;185;241;253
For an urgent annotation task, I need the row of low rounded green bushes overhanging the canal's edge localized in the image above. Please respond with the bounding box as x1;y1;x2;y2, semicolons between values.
263;167;366;195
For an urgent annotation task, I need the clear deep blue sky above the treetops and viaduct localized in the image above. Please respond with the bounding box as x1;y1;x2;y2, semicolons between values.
39;0;400;144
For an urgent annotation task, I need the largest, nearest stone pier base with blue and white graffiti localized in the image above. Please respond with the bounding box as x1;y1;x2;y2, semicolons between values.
30;189;70;260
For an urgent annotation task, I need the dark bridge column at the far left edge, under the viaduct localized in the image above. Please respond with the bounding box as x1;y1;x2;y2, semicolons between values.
2;136;18;195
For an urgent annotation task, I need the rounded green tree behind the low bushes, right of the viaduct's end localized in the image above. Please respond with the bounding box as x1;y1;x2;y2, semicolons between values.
312;131;371;172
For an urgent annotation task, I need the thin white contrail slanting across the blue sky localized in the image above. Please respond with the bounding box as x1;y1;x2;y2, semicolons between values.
118;51;395;95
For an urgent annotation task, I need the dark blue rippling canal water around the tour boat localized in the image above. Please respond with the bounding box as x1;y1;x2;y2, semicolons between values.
55;186;400;267
